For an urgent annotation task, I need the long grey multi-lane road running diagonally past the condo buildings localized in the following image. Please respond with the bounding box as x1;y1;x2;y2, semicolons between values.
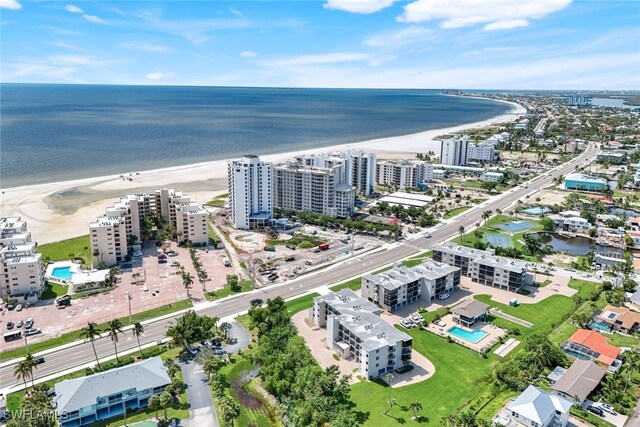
0;144;597;392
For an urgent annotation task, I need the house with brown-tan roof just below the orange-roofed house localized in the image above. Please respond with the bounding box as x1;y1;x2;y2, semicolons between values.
551;359;607;405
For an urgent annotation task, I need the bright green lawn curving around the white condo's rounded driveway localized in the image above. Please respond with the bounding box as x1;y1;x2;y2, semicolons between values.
351;329;497;426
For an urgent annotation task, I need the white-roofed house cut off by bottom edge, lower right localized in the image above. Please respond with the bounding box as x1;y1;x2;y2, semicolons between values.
507;385;571;427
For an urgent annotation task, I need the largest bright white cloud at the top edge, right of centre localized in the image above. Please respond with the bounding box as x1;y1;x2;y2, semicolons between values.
398;0;571;31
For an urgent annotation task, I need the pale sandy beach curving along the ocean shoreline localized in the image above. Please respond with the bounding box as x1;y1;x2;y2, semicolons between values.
0;101;525;244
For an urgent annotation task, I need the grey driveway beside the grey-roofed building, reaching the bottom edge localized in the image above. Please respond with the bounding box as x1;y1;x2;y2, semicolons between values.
180;359;220;427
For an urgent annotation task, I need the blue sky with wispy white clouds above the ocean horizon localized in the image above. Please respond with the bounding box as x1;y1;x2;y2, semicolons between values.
0;0;640;89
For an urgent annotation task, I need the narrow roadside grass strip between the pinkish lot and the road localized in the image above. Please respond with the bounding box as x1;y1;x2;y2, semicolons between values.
0;300;191;362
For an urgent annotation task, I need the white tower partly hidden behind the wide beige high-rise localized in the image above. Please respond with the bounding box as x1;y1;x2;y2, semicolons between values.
295;150;376;196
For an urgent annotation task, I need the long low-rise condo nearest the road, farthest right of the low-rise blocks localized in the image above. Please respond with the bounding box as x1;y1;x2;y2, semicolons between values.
433;243;533;292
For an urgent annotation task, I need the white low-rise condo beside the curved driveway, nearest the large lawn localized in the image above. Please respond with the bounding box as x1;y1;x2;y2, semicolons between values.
308;289;413;379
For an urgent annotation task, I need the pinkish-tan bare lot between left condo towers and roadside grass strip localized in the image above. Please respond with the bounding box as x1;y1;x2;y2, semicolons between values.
0;242;235;350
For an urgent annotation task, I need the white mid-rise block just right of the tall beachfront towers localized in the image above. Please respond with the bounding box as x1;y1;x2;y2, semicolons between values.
376;159;433;190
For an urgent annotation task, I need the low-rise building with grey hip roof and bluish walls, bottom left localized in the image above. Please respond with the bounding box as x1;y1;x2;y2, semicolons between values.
54;357;171;427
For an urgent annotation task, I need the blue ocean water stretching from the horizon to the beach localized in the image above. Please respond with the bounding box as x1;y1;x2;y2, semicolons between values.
0;84;511;188
